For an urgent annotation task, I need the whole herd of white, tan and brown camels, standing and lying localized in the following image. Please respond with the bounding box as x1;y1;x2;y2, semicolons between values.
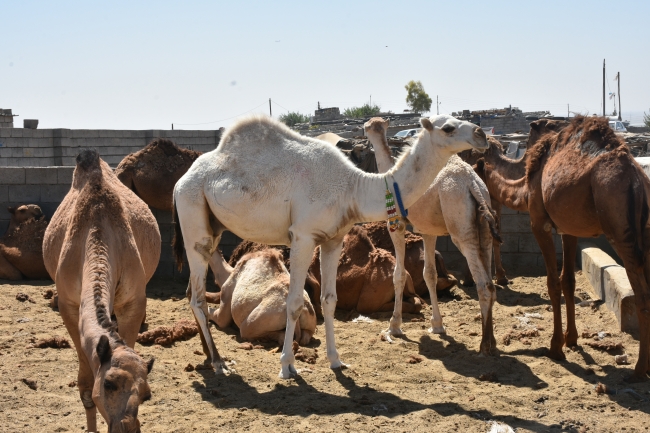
5;115;650;432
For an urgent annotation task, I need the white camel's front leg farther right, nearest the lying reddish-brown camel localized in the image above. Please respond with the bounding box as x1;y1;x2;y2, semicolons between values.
318;238;346;368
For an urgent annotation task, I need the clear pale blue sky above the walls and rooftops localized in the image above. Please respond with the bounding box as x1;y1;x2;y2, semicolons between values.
0;0;650;129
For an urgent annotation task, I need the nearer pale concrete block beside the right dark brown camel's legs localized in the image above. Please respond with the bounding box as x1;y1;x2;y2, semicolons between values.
603;266;639;335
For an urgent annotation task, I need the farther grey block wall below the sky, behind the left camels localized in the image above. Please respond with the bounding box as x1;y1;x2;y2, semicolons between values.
0;128;222;167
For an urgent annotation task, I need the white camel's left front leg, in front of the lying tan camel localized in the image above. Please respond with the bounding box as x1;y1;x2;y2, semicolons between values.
280;233;315;379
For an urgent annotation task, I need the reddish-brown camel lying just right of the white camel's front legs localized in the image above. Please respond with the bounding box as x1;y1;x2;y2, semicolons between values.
309;226;422;314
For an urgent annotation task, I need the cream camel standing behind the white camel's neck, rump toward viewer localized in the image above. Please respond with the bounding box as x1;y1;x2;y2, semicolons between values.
364;117;498;355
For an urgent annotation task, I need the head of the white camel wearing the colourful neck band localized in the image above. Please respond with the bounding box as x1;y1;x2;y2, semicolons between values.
418;114;488;154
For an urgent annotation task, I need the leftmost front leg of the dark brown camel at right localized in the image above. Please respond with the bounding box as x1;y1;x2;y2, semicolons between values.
531;218;566;361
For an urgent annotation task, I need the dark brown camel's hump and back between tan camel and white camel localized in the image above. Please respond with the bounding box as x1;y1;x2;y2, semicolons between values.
115;138;201;210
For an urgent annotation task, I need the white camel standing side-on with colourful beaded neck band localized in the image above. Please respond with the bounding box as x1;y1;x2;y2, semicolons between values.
174;116;487;378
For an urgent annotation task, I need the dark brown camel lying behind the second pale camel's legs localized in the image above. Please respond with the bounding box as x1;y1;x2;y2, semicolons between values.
363;221;458;296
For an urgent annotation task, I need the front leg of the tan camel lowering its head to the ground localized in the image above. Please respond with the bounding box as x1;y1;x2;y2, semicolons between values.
59;300;97;432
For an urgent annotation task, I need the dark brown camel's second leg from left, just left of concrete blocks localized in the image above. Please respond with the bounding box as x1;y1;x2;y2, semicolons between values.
560;235;578;347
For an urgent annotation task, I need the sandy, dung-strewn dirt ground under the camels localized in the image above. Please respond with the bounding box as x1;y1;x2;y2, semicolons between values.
0;272;650;432
